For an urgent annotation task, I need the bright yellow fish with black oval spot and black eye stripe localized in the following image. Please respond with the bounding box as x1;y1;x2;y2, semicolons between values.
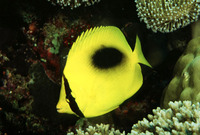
56;26;151;118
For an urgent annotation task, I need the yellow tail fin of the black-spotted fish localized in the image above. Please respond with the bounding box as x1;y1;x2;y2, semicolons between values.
132;35;151;67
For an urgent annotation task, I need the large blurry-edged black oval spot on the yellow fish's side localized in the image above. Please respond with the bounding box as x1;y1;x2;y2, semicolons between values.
92;47;124;69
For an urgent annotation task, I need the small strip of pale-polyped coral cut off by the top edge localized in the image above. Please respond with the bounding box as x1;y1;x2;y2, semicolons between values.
48;0;100;9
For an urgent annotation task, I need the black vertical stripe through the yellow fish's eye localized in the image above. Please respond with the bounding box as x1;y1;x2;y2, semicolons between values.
63;75;85;117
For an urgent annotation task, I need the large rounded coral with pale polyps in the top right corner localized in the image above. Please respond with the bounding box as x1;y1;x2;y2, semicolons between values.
135;0;200;33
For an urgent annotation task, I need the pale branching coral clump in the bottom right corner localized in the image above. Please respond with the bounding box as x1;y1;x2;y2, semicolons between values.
131;101;200;135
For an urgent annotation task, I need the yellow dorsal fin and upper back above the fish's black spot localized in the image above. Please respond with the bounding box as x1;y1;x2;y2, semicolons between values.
69;26;132;60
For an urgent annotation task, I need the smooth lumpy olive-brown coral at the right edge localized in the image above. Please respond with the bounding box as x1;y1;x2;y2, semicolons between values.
161;37;200;108
